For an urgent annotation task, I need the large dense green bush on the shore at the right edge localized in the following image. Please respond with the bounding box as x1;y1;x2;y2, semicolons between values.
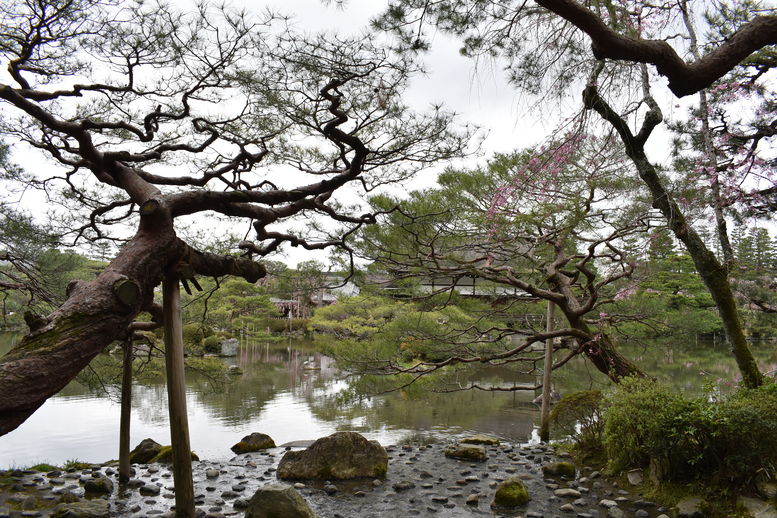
604;379;777;486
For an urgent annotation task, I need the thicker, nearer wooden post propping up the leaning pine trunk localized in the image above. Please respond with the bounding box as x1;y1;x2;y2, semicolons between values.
162;272;194;518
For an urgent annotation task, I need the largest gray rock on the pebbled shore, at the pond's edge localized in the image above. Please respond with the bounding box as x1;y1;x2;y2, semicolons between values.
278;432;388;480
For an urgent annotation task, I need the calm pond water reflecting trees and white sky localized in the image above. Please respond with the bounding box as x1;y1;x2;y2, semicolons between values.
0;334;777;469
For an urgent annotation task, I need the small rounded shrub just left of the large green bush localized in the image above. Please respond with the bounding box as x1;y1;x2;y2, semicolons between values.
550;390;604;450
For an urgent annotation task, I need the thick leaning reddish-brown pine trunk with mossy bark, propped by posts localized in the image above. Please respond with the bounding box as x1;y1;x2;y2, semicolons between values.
0;215;266;435
